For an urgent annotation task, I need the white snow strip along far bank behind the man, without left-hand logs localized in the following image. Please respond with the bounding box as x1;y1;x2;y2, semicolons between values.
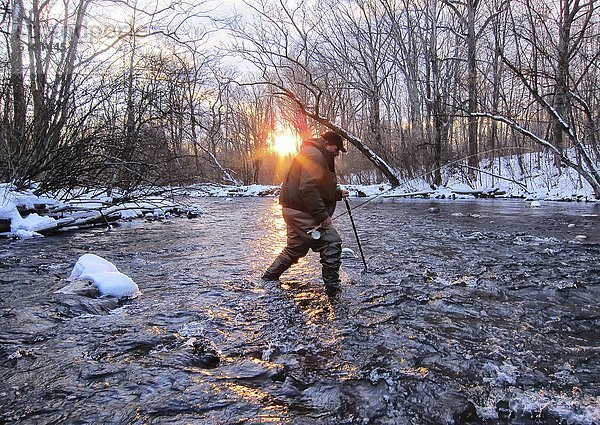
181;152;597;202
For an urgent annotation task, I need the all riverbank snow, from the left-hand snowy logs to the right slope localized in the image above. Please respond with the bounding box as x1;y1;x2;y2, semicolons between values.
0;148;597;238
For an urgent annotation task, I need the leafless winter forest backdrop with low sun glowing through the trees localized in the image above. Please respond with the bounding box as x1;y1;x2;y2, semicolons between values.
0;0;600;198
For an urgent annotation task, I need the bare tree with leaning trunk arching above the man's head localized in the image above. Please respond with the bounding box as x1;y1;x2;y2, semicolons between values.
235;0;399;186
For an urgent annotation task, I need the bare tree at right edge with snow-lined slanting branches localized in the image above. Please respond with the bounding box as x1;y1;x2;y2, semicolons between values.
475;0;600;197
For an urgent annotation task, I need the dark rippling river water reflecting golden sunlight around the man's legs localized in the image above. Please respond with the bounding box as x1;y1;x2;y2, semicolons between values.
0;199;600;424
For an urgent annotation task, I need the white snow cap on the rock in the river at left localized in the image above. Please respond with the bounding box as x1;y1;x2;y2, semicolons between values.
69;254;140;298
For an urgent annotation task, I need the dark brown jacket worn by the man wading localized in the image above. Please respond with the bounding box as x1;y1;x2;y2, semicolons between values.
279;138;342;223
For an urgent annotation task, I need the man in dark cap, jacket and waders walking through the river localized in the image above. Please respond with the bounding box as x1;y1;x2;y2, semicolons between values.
262;131;348;292
